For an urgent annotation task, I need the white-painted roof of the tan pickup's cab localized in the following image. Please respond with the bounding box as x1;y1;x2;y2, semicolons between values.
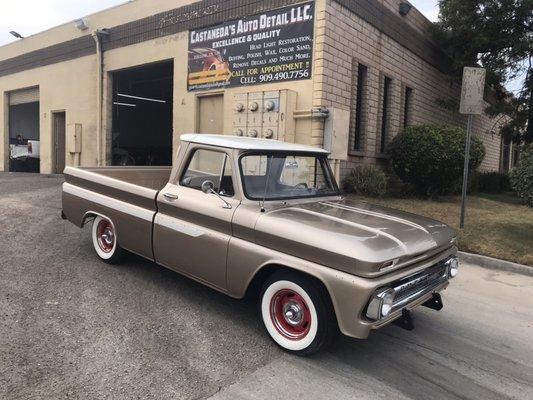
180;133;329;154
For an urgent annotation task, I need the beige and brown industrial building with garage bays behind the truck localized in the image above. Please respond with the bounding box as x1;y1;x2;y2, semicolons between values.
0;0;513;176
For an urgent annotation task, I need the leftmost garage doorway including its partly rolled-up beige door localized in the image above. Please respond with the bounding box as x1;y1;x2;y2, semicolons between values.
9;88;41;172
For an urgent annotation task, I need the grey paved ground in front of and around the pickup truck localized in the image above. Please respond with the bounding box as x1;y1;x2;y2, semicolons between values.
0;173;533;400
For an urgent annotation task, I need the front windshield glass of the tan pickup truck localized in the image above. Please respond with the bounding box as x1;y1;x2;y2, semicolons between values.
240;153;339;200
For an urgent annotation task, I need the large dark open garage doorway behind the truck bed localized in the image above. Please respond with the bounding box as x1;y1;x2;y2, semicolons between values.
112;61;174;166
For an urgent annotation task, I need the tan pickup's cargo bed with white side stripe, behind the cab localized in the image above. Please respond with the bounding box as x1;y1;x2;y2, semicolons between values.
63;167;172;260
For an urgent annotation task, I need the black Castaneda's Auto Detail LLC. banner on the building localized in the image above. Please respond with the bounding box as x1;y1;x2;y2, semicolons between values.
188;2;315;91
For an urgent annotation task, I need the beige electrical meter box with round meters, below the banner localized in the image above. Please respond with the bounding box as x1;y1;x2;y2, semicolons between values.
233;90;297;143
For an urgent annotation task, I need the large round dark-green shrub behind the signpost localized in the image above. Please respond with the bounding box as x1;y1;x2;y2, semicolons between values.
389;125;485;196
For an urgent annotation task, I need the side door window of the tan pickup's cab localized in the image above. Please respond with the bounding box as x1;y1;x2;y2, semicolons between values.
180;149;235;196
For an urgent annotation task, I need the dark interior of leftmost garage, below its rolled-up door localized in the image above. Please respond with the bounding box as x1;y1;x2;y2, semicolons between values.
9;102;40;173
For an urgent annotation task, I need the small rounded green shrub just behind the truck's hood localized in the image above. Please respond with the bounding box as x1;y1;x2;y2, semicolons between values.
344;165;387;197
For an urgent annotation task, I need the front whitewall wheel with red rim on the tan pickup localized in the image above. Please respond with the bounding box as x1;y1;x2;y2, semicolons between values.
259;272;338;356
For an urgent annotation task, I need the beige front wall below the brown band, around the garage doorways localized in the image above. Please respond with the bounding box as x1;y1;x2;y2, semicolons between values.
0;0;324;173
